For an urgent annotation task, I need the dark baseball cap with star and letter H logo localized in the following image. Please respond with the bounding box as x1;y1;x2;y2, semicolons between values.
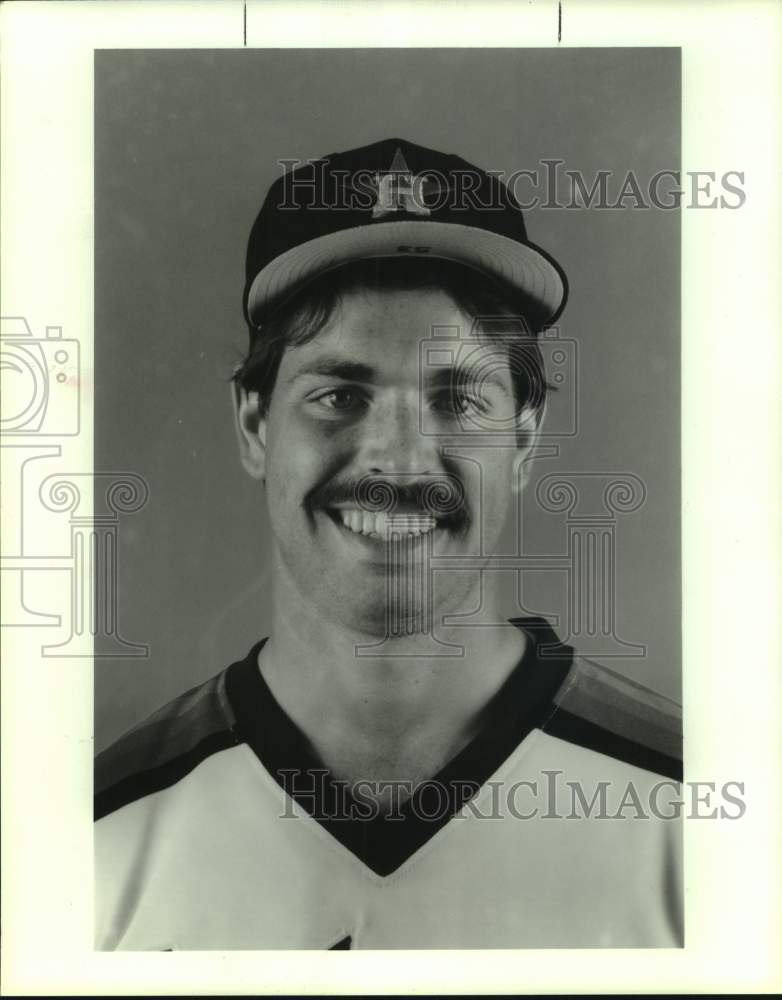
244;138;567;328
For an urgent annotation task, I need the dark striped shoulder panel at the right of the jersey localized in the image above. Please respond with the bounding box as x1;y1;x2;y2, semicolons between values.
542;657;682;781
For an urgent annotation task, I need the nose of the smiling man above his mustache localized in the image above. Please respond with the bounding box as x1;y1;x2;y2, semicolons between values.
361;393;442;478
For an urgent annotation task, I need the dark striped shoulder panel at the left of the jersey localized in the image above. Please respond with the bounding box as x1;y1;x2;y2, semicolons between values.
95;670;238;819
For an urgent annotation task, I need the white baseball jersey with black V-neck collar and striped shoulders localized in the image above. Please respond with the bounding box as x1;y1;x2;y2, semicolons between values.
95;618;683;951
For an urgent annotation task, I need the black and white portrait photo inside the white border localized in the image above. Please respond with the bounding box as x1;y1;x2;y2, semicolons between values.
96;50;688;951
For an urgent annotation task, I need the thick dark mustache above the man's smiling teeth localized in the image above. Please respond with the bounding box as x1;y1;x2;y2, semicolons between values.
307;474;468;527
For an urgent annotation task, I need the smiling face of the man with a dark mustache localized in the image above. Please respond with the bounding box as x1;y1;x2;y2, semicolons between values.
240;289;536;634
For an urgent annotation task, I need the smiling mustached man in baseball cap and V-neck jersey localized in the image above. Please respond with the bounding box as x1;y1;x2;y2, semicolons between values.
96;139;682;950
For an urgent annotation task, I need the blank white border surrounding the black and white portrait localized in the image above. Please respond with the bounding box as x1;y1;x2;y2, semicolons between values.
0;0;782;995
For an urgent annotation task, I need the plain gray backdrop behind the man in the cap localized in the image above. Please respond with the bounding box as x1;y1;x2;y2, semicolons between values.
95;48;681;749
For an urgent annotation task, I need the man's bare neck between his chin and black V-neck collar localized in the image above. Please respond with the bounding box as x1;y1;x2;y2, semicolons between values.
259;572;525;780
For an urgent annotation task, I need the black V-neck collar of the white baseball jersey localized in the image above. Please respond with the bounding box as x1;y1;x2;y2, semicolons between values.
226;618;573;875
